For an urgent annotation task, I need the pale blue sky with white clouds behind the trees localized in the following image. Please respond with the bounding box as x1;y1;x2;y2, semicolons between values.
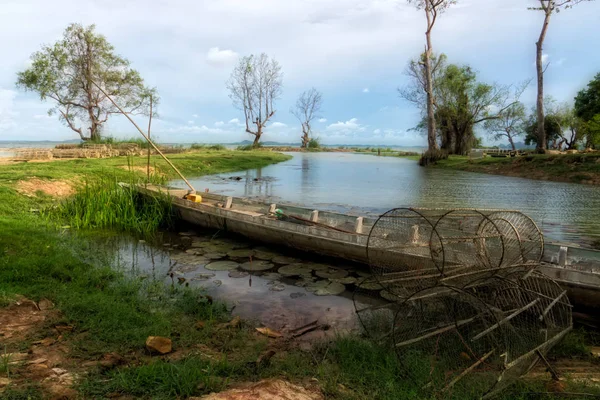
0;0;600;146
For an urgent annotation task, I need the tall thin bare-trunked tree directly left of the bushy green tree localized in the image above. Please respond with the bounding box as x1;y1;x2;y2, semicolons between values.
408;0;456;150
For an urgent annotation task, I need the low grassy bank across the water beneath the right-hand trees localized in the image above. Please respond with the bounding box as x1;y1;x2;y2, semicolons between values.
433;153;600;185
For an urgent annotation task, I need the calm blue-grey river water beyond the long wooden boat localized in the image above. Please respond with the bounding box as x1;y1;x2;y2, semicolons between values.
174;153;600;246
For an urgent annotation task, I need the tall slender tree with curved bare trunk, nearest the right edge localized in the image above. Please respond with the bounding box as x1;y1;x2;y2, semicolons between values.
529;0;593;151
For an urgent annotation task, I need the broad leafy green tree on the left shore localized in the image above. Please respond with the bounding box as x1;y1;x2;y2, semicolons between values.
17;24;158;140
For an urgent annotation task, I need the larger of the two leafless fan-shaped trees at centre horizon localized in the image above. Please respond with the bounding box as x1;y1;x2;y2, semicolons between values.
227;53;283;146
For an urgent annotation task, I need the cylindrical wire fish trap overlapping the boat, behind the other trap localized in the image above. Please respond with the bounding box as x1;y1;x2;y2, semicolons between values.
367;208;543;298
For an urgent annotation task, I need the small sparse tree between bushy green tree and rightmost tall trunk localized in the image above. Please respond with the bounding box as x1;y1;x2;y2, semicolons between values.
484;81;529;151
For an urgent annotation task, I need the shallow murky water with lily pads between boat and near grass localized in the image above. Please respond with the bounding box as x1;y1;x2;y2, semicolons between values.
105;228;372;332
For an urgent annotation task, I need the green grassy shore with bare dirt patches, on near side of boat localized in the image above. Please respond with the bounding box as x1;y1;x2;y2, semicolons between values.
0;151;598;400
